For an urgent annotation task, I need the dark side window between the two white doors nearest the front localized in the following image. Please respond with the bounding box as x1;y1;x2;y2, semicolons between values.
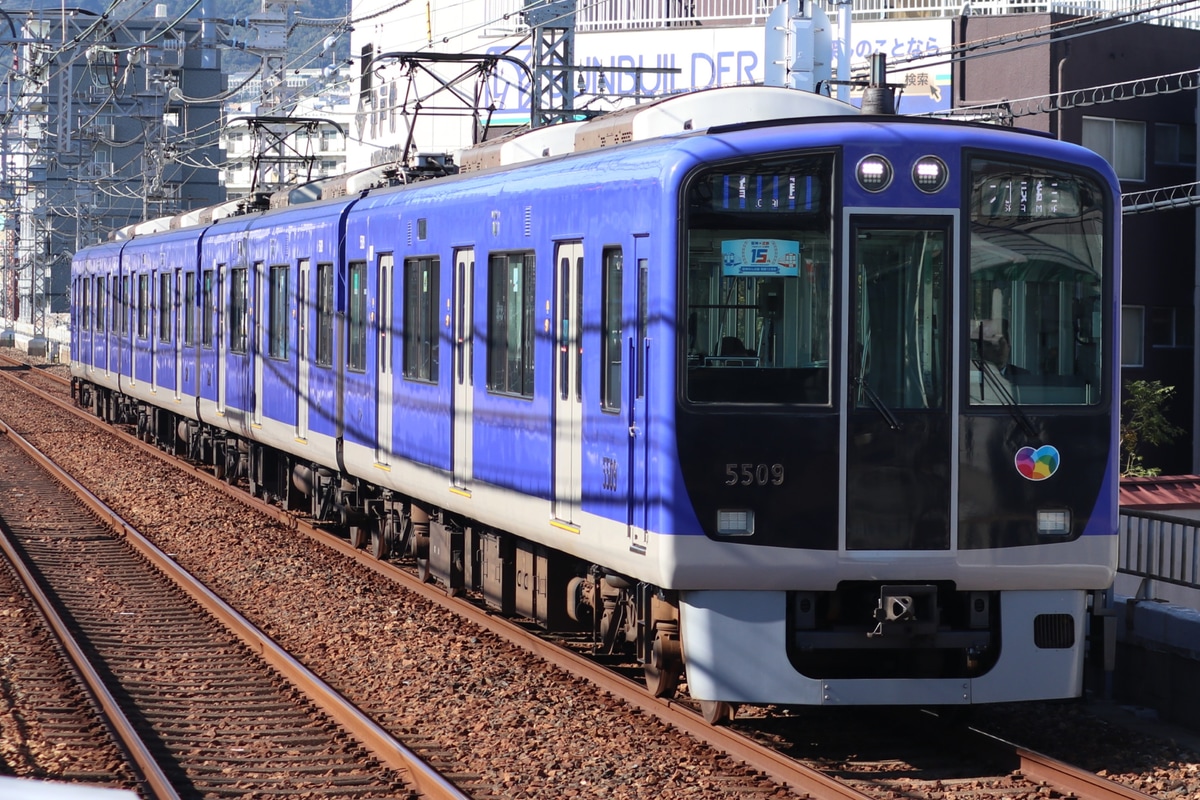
487;251;538;399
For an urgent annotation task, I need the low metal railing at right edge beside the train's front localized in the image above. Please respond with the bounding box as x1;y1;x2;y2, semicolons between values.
1117;511;1200;589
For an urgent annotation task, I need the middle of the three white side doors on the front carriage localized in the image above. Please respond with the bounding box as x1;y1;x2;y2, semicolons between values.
451;248;475;492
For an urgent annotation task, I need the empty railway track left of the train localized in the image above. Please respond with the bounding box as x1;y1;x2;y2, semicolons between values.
0;410;463;798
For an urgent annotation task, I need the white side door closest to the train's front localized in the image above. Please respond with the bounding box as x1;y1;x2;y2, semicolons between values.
553;241;583;524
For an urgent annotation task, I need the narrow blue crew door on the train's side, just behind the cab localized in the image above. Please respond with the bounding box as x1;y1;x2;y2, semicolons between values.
628;245;650;552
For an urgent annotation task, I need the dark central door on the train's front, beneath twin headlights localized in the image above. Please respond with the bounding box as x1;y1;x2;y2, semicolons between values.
841;215;954;551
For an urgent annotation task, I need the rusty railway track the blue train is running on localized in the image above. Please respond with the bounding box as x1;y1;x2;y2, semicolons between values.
0;352;1185;799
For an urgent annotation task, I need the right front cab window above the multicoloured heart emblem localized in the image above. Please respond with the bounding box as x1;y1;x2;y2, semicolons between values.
962;158;1111;405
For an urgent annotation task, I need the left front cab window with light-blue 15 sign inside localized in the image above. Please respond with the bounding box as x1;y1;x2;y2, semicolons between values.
679;152;834;404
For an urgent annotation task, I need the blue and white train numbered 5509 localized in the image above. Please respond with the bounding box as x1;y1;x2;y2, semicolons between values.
72;86;1121;722
